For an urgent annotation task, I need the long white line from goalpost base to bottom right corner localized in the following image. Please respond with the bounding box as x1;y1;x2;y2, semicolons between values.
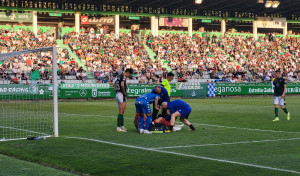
65;137;300;174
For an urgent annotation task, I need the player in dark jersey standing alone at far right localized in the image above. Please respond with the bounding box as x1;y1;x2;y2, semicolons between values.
273;70;291;122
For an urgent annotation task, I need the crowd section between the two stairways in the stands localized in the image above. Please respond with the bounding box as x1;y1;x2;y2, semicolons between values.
64;29;166;83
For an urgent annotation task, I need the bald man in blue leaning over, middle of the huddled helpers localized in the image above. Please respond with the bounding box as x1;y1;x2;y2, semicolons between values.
151;86;170;121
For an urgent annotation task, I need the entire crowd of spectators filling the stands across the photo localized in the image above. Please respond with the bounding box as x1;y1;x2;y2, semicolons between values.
0;26;300;84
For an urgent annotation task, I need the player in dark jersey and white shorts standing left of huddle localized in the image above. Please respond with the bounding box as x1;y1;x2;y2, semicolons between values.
114;69;133;132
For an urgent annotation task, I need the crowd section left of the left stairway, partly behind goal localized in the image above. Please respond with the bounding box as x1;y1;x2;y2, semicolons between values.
0;27;85;83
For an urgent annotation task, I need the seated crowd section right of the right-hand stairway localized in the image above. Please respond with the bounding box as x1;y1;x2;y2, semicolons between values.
147;33;300;83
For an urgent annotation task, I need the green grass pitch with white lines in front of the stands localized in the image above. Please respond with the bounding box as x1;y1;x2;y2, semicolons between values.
0;96;300;176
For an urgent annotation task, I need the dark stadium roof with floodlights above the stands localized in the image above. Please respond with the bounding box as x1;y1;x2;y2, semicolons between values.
59;0;300;16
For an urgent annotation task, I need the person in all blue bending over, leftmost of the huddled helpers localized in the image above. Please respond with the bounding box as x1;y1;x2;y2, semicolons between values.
135;93;159;134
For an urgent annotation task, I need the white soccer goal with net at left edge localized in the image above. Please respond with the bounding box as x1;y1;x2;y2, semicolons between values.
0;46;58;141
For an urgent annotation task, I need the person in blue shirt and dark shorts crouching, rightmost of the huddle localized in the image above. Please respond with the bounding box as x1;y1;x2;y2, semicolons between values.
162;100;195;130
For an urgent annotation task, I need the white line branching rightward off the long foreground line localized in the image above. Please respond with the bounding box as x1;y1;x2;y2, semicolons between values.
151;138;300;150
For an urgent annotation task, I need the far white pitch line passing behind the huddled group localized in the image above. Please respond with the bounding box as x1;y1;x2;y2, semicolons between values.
59;113;300;134
